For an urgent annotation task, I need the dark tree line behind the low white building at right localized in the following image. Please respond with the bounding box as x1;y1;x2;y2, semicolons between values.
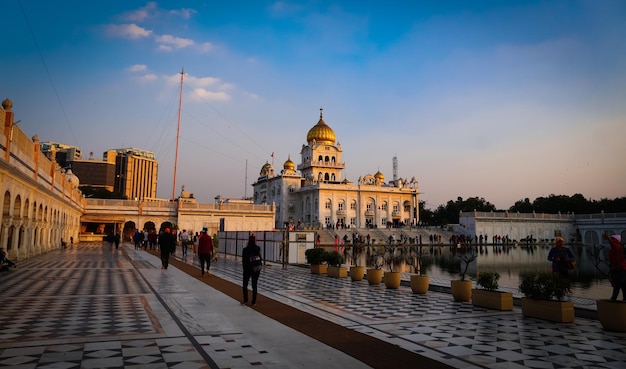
419;194;626;226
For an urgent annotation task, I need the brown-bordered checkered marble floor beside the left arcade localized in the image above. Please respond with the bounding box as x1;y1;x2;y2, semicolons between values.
0;245;209;369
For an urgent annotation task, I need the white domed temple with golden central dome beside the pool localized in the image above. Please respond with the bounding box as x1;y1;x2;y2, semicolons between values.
252;109;419;228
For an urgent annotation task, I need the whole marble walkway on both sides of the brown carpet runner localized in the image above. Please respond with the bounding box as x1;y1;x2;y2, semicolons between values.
0;244;626;368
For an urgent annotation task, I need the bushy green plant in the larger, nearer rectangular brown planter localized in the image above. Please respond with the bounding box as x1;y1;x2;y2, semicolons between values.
519;272;574;323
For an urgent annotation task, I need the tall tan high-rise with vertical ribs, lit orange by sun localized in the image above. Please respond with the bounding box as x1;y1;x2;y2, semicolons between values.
104;148;159;199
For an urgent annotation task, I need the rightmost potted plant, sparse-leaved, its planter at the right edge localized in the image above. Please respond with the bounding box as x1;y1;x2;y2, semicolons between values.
592;237;626;332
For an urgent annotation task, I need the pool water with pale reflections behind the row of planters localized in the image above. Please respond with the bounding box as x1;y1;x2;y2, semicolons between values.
354;245;612;299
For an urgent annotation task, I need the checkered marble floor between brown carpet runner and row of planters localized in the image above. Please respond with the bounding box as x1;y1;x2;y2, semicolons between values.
197;253;626;369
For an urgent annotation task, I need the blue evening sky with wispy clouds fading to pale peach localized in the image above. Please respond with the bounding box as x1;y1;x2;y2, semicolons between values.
0;0;626;210
